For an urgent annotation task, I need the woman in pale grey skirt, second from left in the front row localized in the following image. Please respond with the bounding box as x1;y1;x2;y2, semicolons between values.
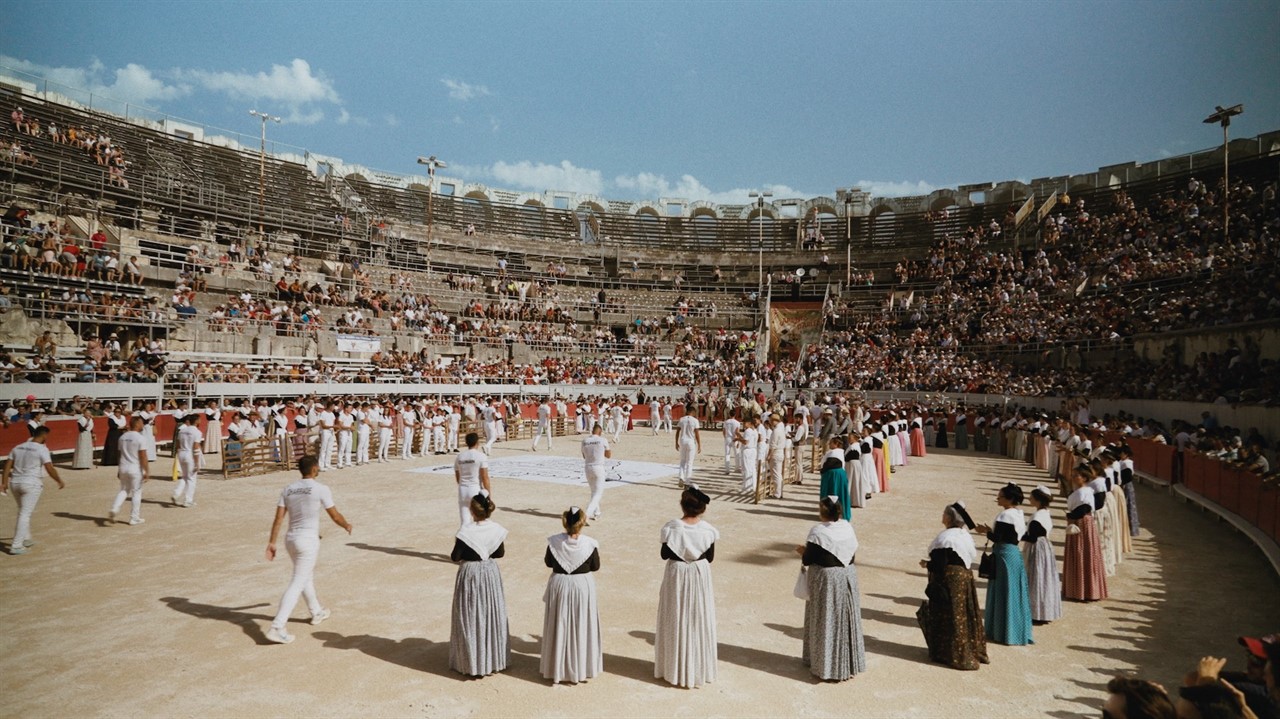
541;507;604;683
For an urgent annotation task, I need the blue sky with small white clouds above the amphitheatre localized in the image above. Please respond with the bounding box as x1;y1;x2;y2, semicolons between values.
0;0;1280;202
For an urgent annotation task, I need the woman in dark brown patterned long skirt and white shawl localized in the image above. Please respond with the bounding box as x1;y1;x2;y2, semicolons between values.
915;502;988;670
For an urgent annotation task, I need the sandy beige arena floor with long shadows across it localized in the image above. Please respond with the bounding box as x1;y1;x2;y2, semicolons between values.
0;429;1280;718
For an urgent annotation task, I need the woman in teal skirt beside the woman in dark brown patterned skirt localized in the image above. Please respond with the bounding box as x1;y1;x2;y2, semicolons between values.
978;482;1033;646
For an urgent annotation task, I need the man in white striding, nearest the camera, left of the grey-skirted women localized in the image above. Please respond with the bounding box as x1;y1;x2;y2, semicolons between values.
266;454;351;644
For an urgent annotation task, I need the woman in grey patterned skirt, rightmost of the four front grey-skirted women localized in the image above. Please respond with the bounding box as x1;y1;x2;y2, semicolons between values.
796;496;867;682
